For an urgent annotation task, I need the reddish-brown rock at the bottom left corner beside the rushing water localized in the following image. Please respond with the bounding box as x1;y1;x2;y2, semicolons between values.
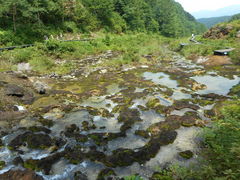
0;170;44;180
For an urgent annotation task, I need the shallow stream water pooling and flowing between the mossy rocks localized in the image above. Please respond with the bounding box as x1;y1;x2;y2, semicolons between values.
0;57;240;180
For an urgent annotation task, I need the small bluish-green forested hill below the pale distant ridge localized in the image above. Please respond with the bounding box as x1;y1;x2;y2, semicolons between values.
197;16;232;28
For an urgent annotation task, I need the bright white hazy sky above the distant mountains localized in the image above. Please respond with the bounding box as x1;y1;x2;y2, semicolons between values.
175;0;240;13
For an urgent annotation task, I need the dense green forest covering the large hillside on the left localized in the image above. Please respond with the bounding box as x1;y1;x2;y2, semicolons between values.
0;0;205;43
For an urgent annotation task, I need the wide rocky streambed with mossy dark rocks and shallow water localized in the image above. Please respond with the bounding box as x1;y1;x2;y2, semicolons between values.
0;56;240;180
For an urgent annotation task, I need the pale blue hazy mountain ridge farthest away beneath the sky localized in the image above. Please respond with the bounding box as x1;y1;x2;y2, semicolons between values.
192;4;240;19
